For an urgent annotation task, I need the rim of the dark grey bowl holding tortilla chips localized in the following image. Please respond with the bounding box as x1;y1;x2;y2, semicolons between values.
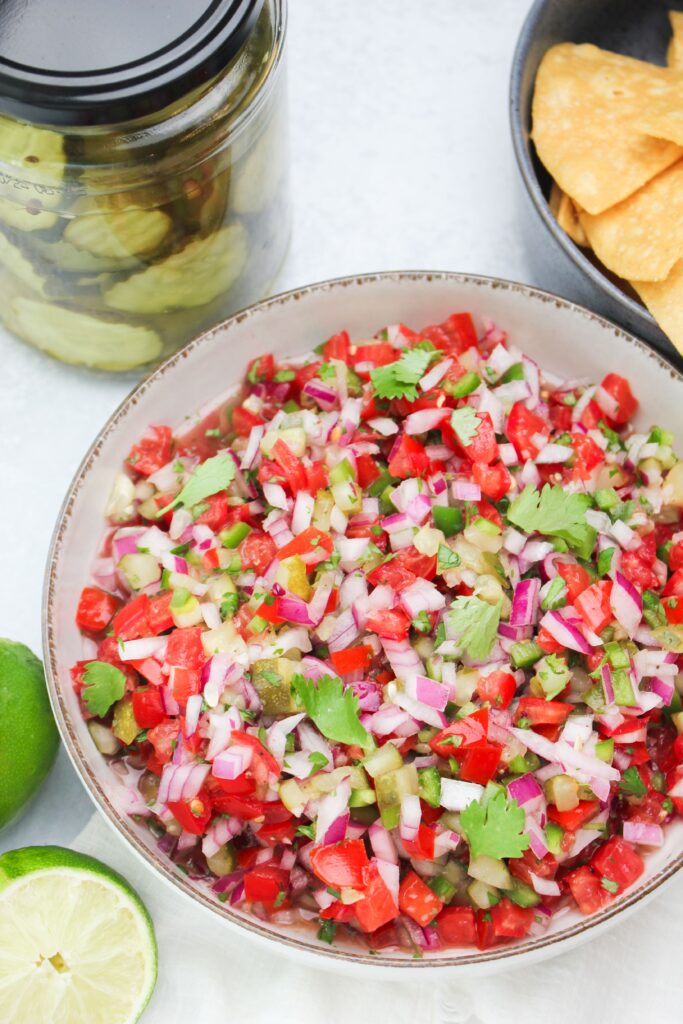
509;0;674;349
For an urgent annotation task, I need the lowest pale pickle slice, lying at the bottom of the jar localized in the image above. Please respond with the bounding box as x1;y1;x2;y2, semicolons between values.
6;297;162;370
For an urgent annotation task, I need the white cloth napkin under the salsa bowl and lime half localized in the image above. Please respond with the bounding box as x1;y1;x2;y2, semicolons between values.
73;814;683;1024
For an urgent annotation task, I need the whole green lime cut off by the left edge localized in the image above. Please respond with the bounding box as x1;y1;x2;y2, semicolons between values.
0;638;59;828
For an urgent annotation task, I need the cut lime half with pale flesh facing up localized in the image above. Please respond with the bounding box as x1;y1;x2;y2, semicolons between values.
0;846;157;1024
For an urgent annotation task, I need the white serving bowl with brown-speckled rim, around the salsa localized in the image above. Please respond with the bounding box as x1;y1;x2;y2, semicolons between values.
43;272;683;976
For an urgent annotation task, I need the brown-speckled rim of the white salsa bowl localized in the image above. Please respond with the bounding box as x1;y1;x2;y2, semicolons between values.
41;270;683;973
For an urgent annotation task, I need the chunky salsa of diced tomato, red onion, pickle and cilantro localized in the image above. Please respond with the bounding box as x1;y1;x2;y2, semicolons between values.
72;313;683;954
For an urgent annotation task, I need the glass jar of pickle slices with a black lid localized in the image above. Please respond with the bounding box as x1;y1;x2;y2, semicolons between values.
0;0;290;371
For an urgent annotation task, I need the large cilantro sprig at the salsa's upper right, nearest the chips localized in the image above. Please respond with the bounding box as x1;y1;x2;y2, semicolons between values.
507;483;597;558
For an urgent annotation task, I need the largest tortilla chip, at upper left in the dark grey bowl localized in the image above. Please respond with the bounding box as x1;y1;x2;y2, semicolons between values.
532;43;683;214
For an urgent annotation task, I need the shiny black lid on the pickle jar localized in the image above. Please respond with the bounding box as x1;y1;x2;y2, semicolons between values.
0;0;264;126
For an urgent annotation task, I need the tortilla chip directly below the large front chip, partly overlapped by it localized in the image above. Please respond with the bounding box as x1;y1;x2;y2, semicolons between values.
580;160;683;281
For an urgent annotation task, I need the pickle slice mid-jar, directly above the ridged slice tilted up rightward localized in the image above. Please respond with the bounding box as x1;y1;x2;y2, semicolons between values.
63;195;172;260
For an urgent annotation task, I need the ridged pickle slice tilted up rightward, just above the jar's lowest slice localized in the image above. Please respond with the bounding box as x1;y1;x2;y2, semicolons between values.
104;223;249;313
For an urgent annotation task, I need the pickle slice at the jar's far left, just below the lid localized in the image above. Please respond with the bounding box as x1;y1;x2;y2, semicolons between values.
0;117;65;231
